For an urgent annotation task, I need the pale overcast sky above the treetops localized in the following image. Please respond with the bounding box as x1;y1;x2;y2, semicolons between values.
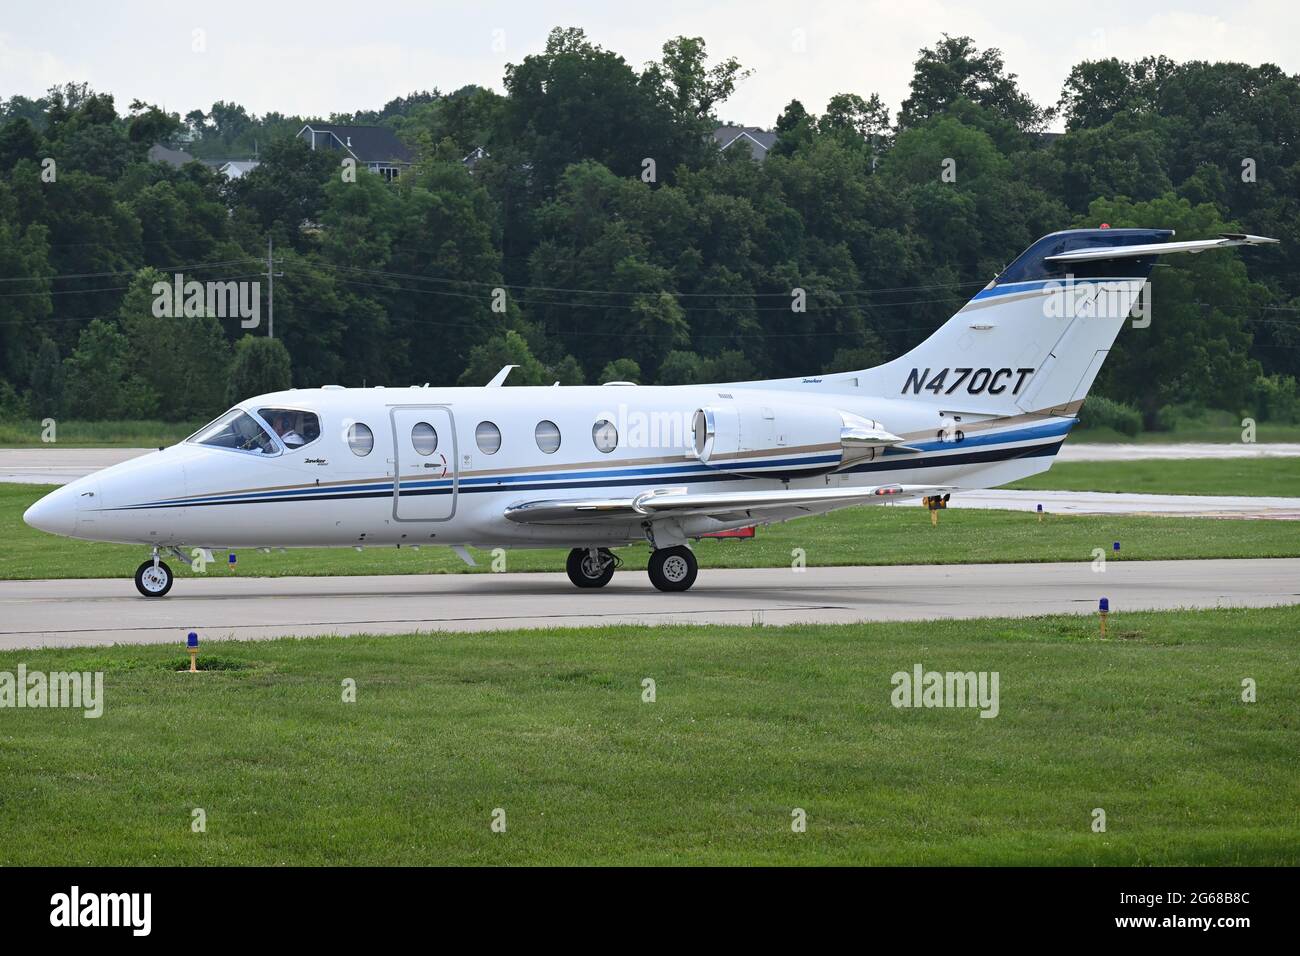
0;0;1300;126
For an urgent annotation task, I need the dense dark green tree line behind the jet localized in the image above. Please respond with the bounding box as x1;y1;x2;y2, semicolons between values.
0;29;1300;427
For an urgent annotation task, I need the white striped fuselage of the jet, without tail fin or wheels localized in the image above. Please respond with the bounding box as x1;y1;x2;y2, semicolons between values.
26;376;1075;549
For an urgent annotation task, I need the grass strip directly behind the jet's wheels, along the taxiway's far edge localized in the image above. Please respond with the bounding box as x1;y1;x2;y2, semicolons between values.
0;485;1300;579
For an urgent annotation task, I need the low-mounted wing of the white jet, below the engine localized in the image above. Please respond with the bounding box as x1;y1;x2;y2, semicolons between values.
506;485;952;524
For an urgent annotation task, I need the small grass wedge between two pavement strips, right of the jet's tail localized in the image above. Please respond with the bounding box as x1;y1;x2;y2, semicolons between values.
1006;458;1300;498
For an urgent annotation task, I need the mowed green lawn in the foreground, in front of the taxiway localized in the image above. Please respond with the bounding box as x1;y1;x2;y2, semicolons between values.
0;607;1300;865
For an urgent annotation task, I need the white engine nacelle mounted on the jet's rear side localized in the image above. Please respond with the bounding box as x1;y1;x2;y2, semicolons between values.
692;403;902;475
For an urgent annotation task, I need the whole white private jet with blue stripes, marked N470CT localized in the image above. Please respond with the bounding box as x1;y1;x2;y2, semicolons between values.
23;228;1275;597
